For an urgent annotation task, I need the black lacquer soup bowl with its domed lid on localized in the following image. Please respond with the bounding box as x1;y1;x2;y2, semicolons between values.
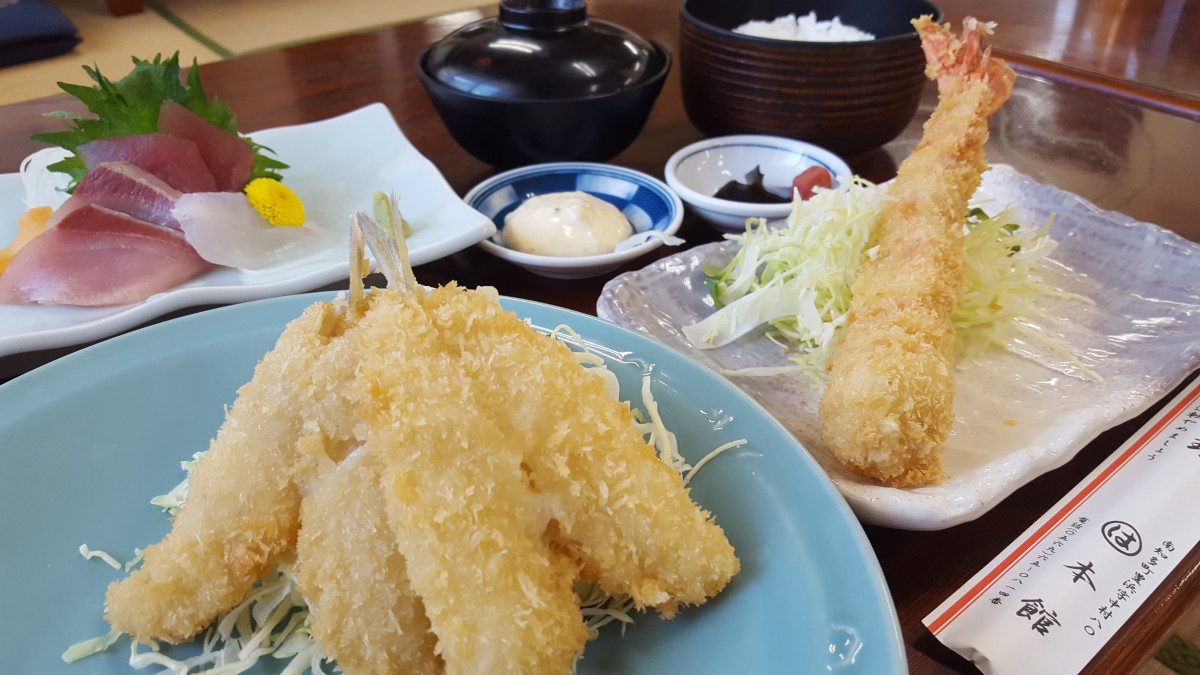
416;0;671;168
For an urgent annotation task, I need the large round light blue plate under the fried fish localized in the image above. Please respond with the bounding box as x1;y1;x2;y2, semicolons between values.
0;294;906;675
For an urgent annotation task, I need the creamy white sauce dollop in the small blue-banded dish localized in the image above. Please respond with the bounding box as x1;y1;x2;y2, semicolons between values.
500;192;634;257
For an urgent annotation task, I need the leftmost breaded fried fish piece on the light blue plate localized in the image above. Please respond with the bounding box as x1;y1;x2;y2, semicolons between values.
106;300;343;643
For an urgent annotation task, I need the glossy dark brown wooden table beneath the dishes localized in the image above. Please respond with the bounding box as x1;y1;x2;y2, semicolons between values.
0;0;1200;673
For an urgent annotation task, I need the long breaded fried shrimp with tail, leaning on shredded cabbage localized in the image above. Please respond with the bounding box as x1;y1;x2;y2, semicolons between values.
820;17;1015;488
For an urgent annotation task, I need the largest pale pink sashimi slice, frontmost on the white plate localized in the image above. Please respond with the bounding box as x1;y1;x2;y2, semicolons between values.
0;199;211;306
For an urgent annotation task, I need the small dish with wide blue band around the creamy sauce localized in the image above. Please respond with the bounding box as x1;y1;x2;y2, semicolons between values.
463;162;683;279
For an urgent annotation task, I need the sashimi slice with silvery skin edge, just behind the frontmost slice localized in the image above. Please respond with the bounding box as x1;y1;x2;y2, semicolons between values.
47;162;184;229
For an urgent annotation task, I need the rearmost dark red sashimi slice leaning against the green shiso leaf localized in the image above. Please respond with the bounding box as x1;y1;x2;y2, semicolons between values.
158;101;254;192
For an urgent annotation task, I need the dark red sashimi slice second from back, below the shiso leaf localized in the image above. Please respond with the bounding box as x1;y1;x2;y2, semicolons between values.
76;133;217;192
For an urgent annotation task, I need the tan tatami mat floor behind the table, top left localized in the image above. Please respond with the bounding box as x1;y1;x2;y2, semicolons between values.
0;0;496;104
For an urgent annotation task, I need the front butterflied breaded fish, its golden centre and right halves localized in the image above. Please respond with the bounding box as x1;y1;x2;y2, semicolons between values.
359;286;739;674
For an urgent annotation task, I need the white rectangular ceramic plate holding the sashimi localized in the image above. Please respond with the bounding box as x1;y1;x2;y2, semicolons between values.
0;103;496;357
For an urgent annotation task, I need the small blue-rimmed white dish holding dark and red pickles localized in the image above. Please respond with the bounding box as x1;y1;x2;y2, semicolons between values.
664;133;853;231
